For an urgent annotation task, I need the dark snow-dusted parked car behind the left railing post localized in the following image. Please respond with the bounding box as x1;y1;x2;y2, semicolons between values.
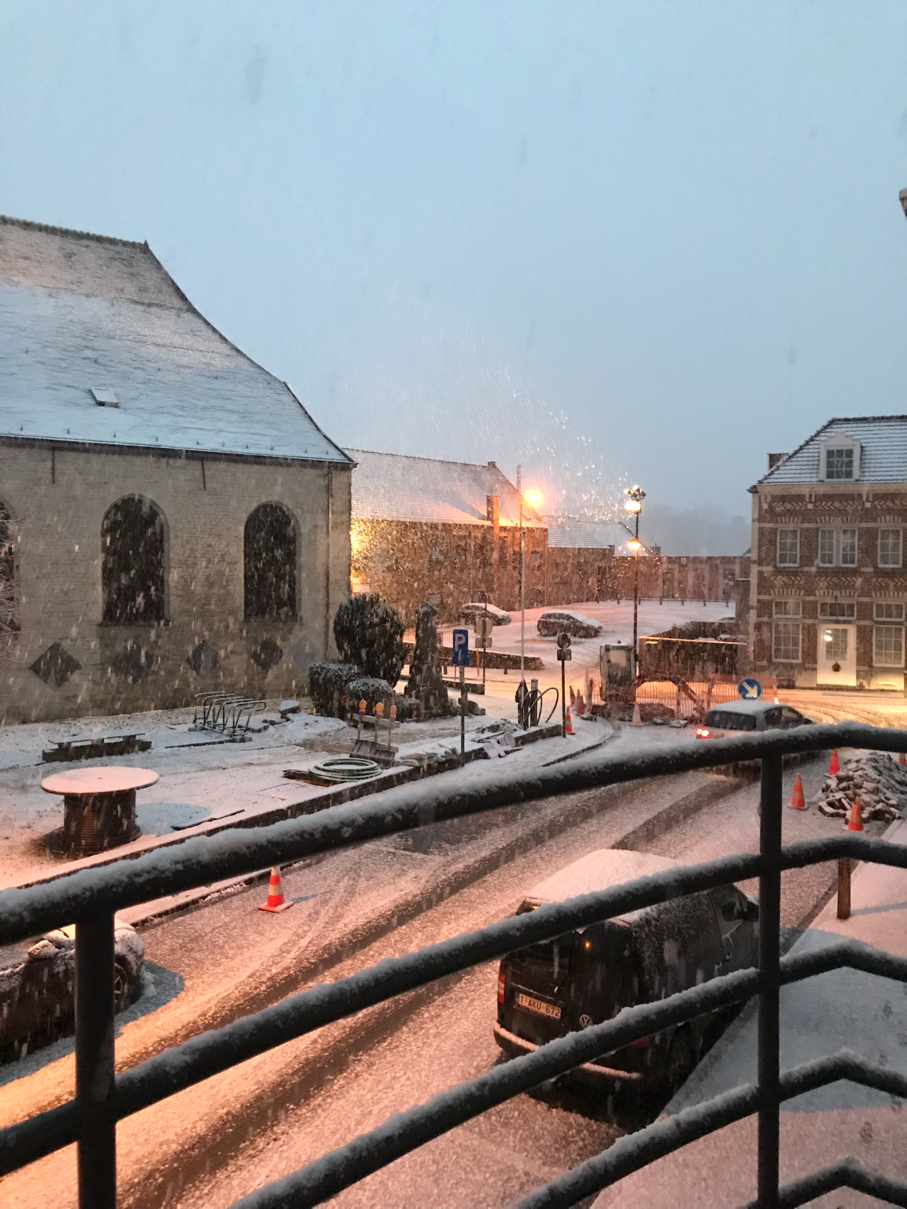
0;919;145;1063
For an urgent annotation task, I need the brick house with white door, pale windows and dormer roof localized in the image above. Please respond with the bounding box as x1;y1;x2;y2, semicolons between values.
750;416;907;692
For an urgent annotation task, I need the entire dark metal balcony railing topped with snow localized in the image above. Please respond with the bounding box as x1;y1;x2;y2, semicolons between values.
0;723;907;1209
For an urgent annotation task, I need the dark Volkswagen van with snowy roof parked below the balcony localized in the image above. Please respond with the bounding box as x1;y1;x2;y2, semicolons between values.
495;849;758;1093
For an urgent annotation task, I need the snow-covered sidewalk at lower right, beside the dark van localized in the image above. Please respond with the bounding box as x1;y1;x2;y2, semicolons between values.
595;821;907;1209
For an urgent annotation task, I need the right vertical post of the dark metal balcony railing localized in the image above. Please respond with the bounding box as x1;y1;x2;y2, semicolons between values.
758;756;781;1209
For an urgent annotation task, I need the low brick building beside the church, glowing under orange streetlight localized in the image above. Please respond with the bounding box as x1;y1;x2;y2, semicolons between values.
347;450;545;625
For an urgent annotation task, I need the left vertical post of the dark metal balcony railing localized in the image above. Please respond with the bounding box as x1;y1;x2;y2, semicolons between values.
75;912;116;1209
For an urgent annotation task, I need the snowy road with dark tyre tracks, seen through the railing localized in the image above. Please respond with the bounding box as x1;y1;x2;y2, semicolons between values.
0;749;880;1209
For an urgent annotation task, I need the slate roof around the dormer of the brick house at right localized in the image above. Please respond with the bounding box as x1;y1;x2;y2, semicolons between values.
756;416;907;486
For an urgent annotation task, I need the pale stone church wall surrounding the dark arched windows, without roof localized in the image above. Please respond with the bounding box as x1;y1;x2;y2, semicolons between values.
0;442;349;722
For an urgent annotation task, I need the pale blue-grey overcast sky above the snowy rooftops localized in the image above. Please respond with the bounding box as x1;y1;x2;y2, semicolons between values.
0;0;907;539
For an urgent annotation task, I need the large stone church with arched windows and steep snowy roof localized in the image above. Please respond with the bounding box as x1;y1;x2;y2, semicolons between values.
0;219;352;721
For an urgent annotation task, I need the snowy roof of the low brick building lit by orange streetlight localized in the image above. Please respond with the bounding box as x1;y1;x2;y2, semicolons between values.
347;450;544;528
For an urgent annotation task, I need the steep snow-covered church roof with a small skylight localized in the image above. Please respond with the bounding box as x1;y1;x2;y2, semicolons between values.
0;218;349;463
